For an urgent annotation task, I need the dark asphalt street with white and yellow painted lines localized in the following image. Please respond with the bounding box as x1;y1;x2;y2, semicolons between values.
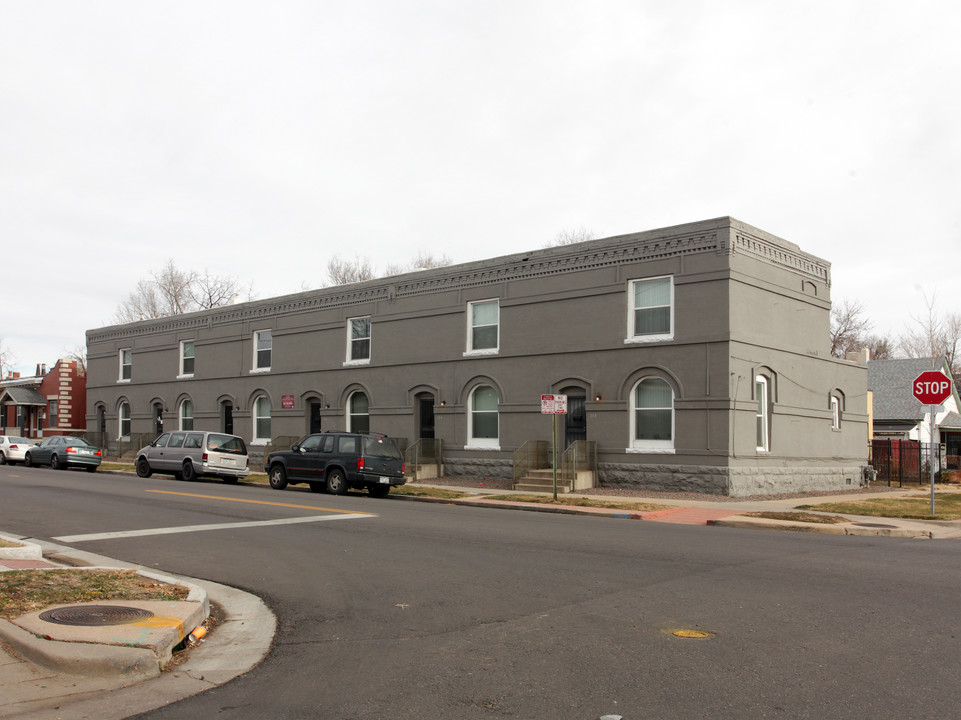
0;467;961;720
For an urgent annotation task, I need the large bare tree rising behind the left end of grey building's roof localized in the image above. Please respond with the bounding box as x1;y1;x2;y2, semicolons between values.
114;260;253;323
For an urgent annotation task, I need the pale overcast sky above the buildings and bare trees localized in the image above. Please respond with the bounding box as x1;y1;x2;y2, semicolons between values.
0;0;961;374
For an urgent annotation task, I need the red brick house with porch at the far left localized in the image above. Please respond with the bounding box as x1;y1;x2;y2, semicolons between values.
0;360;87;438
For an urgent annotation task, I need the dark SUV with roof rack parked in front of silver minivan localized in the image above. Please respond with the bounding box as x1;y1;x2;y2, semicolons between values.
264;432;406;497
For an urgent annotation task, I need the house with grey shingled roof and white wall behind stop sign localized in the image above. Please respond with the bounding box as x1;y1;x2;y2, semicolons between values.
868;358;961;467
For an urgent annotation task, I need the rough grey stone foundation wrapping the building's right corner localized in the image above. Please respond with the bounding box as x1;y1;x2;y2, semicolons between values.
598;463;865;497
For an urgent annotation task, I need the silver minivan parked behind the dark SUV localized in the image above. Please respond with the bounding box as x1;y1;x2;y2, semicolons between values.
137;430;250;482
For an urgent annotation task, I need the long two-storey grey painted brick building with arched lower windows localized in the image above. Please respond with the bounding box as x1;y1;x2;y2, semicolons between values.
87;217;868;495
